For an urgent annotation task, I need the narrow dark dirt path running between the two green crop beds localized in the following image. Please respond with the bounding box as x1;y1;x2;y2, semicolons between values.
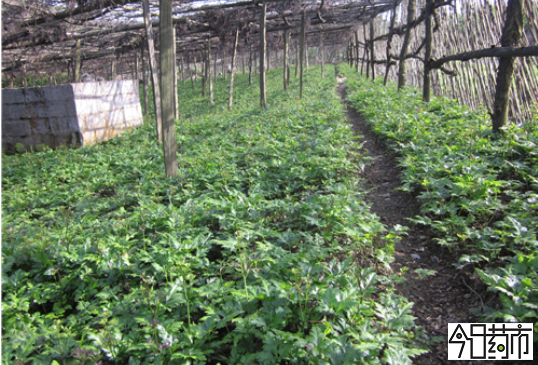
337;83;502;365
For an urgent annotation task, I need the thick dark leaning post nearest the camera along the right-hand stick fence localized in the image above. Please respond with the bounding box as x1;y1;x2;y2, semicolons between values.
492;0;524;133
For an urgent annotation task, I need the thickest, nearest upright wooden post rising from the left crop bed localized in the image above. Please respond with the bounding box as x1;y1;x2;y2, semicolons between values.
159;0;178;177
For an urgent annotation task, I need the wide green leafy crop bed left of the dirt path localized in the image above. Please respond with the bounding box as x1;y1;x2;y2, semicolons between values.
2;69;427;364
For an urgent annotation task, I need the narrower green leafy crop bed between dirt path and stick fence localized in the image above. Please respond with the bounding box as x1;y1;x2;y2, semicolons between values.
342;67;538;332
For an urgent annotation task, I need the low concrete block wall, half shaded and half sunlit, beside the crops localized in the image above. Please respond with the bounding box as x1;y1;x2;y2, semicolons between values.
2;80;143;152
